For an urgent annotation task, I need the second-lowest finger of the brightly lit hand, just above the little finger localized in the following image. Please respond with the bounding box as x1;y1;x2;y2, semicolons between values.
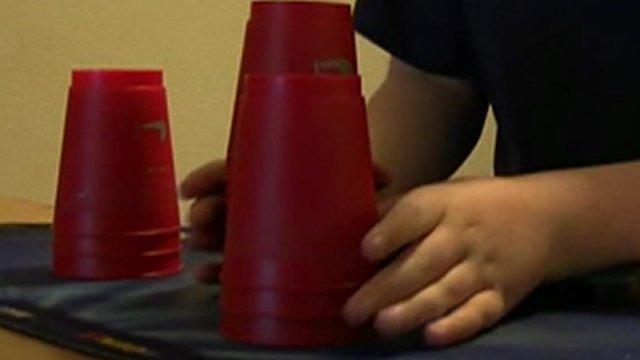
374;263;484;336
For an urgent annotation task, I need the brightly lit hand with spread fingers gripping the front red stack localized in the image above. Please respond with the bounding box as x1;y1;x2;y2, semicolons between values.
345;178;555;345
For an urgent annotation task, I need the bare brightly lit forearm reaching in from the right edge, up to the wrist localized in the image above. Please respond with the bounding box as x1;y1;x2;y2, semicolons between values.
519;161;640;278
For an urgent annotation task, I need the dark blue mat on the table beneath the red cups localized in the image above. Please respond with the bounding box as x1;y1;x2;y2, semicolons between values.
0;226;640;360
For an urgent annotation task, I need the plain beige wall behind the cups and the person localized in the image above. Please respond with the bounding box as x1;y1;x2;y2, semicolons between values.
0;0;492;207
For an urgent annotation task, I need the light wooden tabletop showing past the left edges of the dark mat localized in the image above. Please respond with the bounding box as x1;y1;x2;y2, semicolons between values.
0;196;92;360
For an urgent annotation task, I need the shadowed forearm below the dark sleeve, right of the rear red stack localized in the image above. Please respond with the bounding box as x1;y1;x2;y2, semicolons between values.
368;60;487;193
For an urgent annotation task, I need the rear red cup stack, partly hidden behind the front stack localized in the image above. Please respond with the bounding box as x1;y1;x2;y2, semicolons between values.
227;1;358;174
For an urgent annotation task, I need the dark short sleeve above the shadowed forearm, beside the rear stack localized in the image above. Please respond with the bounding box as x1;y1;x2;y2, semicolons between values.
354;0;474;77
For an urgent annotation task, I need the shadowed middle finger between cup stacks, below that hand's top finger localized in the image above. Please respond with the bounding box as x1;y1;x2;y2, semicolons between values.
187;196;226;250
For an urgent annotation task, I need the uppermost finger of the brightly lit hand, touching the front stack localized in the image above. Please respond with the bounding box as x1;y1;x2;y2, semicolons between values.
362;190;444;261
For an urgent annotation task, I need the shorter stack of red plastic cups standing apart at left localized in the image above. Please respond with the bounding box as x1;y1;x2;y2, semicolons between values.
53;70;182;279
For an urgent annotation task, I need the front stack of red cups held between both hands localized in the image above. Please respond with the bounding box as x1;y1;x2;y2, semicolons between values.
221;75;377;346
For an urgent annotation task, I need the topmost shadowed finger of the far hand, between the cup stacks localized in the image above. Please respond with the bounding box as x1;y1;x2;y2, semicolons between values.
180;160;226;199
